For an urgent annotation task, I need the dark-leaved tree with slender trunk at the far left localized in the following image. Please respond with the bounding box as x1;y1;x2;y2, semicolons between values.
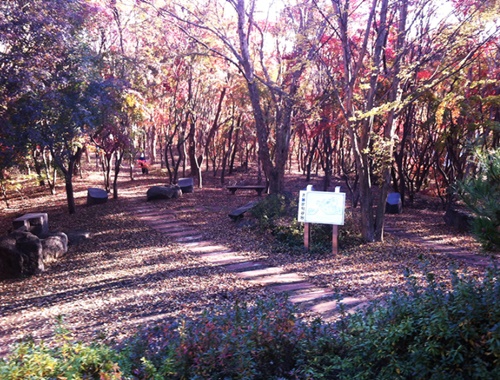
0;0;101;213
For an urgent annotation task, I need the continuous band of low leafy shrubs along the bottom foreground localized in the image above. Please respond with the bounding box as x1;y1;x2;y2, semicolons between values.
0;267;500;380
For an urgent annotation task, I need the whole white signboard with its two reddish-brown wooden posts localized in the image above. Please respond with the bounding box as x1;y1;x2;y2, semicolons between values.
297;185;345;255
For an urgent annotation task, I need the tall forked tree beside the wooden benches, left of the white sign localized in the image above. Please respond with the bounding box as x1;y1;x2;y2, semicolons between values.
141;0;322;193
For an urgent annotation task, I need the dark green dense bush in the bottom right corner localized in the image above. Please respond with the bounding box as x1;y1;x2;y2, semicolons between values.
300;268;500;379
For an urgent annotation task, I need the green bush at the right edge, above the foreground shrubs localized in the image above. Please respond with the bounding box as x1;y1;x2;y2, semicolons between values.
457;149;500;250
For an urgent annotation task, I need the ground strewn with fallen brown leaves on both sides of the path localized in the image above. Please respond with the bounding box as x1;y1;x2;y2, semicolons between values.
0;165;494;355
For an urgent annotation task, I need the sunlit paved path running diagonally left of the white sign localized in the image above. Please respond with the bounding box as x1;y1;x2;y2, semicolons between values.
130;204;368;321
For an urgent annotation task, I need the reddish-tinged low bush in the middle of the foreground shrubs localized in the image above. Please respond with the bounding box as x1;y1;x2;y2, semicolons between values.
121;298;328;379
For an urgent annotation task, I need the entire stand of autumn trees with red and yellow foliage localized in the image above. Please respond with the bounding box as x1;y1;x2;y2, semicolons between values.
0;0;500;241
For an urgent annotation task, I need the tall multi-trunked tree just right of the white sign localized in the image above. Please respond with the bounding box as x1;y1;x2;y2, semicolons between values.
323;0;498;241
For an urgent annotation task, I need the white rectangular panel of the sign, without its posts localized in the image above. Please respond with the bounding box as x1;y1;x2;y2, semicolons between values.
297;186;345;226
